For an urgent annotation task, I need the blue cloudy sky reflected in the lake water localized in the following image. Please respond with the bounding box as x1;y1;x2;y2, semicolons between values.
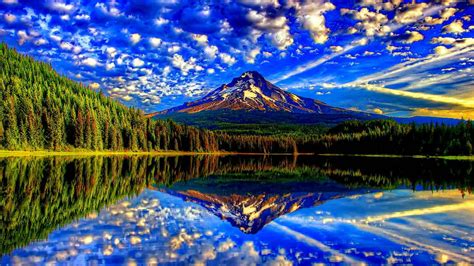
1;189;474;265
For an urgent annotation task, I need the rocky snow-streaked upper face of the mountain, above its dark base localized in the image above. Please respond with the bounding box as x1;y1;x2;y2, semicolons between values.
152;71;350;116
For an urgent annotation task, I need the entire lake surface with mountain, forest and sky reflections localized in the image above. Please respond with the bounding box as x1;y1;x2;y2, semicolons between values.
0;156;474;265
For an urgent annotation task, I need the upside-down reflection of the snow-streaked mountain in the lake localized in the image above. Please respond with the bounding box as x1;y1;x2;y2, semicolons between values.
156;176;379;234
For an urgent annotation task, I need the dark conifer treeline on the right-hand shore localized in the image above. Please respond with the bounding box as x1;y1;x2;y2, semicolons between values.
297;120;474;155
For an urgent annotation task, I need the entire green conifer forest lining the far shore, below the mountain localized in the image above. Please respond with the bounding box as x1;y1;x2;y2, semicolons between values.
0;44;474;155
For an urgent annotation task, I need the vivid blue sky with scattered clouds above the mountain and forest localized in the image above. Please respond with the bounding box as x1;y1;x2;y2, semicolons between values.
0;0;474;118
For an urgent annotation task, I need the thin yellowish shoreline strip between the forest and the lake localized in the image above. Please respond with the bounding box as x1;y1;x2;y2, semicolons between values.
0;150;474;160
